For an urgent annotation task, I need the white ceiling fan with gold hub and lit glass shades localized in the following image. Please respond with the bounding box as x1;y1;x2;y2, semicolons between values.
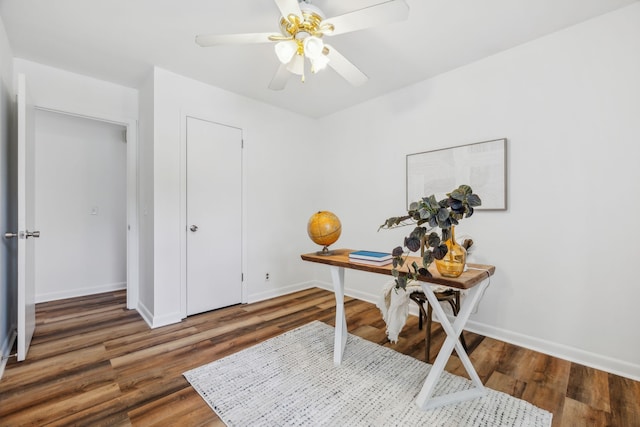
196;0;409;90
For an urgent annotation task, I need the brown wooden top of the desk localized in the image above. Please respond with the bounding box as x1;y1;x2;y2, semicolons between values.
301;249;496;289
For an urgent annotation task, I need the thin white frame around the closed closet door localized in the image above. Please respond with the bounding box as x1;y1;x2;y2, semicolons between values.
180;111;247;319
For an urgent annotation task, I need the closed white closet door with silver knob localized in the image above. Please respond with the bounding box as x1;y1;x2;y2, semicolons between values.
186;117;242;315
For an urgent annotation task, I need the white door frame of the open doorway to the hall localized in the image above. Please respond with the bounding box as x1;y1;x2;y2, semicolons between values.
34;105;140;310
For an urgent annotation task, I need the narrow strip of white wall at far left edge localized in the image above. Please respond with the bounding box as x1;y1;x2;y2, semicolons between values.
0;13;18;378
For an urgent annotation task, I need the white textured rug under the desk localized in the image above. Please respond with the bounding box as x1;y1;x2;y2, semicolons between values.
184;321;552;427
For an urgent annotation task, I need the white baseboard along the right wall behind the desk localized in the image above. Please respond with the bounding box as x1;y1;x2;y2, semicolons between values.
315;282;640;381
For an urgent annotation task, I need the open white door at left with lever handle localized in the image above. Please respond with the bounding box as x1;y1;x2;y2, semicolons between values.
17;74;40;361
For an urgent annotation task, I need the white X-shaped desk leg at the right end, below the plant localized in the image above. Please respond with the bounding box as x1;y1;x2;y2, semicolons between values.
416;280;489;410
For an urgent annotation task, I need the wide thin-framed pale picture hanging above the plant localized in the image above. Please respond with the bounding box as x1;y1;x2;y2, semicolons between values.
407;138;507;210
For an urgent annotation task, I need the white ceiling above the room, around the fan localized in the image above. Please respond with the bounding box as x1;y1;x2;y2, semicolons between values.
0;0;636;117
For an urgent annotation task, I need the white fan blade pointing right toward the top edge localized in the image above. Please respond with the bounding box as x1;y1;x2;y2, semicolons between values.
322;0;409;36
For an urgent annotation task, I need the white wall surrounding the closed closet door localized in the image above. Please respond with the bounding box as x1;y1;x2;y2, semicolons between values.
141;68;323;326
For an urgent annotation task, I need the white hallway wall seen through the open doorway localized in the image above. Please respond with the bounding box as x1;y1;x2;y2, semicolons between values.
35;110;127;302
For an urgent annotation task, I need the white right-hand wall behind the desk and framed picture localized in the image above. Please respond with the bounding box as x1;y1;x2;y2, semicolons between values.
318;4;640;379
